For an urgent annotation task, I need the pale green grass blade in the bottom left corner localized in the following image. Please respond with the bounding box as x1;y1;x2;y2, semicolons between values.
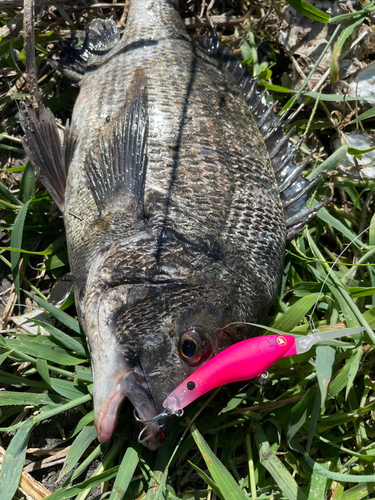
0;419;34;500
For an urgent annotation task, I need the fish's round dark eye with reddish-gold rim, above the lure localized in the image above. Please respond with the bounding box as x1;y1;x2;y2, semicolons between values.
178;326;211;366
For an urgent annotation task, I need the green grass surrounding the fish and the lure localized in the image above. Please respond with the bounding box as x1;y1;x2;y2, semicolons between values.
0;1;375;500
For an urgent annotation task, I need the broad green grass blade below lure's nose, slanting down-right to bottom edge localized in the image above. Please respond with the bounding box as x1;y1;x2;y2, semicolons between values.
190;425;246;500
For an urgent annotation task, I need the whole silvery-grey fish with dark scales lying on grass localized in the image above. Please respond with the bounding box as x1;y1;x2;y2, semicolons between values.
21;0;326;450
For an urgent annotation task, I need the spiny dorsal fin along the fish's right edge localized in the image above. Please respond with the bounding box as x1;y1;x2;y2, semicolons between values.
200;30;330;239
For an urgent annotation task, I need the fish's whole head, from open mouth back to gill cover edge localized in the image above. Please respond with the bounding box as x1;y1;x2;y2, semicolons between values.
78;232;260;449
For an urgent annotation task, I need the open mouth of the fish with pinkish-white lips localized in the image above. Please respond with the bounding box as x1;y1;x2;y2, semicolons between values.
94;367;166;450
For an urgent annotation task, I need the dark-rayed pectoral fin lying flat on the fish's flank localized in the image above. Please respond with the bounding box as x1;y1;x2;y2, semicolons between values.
87;67;148;219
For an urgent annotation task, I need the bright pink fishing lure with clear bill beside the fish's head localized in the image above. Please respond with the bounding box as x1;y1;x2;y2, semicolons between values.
163;327;364;413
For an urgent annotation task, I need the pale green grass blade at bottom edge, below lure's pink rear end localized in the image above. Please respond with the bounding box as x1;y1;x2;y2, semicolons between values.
253;420;306;500
